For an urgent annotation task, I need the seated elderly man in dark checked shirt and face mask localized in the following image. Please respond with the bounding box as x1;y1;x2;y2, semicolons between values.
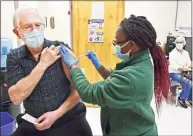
7;8;92;136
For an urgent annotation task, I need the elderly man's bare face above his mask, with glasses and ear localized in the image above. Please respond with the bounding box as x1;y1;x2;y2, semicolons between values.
13;11;44;40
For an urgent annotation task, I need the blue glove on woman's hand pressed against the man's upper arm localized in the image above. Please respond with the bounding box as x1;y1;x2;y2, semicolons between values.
60;46;78;67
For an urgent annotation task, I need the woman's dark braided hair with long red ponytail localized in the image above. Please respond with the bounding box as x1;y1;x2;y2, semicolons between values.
120;15;170;111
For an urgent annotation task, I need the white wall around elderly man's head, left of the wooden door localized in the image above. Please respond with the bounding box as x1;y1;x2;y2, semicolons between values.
1;1;71;47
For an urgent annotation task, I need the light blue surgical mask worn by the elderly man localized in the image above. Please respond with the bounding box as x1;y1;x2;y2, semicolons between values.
23;30;44;48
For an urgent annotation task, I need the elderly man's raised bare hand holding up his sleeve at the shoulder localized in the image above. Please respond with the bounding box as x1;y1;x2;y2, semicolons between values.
40;45;61;69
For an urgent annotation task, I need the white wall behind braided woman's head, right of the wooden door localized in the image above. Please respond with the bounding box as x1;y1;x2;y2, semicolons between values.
125;1;177;42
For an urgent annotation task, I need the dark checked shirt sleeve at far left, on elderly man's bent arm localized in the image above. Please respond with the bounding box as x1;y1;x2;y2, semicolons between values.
7;54;25;88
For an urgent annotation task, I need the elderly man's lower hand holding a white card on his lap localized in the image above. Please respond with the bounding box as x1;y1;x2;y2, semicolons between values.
34;111;59;131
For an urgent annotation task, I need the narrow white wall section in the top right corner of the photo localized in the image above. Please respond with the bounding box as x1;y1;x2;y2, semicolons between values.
176;1;192;27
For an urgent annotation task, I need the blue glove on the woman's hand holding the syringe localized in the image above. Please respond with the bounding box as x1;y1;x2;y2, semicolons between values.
86;50;101;69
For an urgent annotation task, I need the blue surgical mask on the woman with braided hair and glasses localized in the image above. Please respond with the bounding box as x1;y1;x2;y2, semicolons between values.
113;41;130;61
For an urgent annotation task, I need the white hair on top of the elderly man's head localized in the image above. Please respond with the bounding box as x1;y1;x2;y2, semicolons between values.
13;7;41;28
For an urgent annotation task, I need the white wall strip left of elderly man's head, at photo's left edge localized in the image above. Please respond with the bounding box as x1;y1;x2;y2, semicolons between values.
1;1;17;48
